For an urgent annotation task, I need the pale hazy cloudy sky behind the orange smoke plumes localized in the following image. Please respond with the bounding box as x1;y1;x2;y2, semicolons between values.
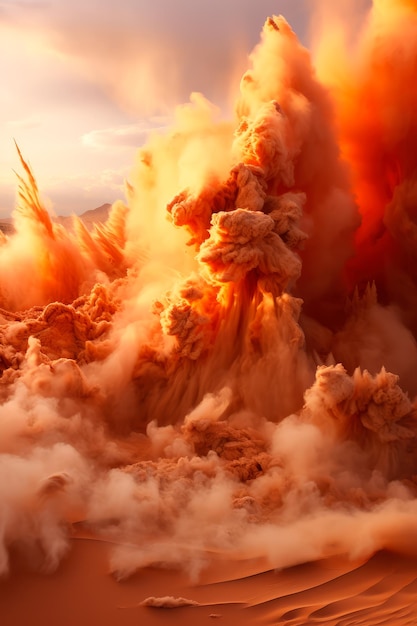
0;0;354;216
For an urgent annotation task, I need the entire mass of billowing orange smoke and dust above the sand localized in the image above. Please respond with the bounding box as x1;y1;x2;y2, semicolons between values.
0;0;417;576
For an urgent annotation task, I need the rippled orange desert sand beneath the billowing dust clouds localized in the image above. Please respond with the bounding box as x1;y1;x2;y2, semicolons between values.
0;537;417;626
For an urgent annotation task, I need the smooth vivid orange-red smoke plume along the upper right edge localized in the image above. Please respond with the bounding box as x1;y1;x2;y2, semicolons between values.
319;0;417;316
